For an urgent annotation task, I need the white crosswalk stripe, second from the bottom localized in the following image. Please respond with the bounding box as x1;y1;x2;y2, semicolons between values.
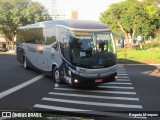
42;97;142;109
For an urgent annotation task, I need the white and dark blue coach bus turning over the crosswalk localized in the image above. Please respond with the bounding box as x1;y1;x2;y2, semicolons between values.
16;20;121;86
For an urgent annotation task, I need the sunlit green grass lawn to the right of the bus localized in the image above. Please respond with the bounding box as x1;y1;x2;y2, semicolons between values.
117;48;160;64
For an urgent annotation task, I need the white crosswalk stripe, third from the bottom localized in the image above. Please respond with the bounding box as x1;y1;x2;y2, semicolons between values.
49;92;139;101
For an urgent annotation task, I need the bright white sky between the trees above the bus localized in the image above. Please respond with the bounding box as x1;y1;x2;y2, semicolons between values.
33;0;123;21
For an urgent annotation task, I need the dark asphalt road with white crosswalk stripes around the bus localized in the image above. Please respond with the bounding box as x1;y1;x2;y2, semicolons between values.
0;54;160;119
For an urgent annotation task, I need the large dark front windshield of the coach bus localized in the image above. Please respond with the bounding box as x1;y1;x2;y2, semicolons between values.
70;31;116;67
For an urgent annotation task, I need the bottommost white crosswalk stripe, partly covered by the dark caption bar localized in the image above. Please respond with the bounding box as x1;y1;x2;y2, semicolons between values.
33;104;146;119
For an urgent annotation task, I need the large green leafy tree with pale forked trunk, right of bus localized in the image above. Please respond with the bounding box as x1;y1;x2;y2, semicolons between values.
100;0;160;43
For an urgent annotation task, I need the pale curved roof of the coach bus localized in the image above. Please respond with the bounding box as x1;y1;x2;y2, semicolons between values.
19;20;110;30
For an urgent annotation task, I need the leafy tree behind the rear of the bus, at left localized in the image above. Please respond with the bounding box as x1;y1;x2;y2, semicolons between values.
0;0;50;49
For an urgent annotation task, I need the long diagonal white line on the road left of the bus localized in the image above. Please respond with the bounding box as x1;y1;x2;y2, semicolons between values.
0;74;45;99
